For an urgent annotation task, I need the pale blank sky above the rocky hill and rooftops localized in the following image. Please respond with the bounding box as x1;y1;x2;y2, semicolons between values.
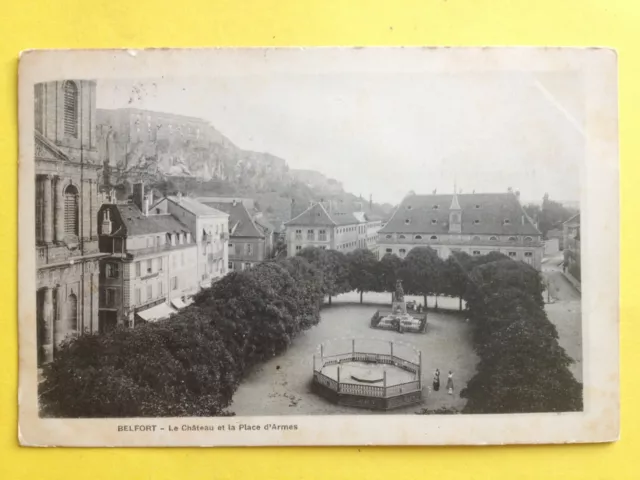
97;71;585;204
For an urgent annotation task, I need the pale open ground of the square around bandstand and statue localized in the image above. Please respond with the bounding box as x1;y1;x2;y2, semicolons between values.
229;293;477;416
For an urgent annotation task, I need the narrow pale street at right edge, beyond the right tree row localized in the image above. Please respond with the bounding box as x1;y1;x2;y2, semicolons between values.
542;253;583;382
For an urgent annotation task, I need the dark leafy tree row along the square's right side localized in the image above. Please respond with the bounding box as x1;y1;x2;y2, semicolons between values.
461;259;583;413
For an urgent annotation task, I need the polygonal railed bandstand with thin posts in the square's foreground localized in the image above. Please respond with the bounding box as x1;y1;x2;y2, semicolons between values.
313;339;422;410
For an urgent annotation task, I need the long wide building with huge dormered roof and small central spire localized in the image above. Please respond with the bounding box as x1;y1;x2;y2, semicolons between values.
378;189;544;269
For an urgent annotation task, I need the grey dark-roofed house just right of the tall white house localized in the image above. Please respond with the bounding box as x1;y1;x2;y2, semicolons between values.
199;198;274;271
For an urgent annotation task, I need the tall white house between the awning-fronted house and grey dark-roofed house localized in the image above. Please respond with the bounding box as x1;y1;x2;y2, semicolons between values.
151;194;229;288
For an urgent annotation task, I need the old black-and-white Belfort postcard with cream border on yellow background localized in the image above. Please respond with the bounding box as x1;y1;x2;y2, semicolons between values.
19;48;619;447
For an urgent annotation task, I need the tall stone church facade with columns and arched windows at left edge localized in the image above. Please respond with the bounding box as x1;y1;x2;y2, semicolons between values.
34;80;102;363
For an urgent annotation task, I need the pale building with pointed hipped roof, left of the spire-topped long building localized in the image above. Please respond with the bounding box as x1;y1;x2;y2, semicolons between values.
284;202;382;257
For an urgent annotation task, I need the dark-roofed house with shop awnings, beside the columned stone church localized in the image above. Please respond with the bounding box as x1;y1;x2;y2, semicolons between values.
99;184;199;332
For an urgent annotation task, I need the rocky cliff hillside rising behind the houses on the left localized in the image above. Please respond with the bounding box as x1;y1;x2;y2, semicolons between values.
98;110;392;227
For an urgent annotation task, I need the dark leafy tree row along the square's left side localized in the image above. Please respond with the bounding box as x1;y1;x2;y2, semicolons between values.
39;258;322;418
